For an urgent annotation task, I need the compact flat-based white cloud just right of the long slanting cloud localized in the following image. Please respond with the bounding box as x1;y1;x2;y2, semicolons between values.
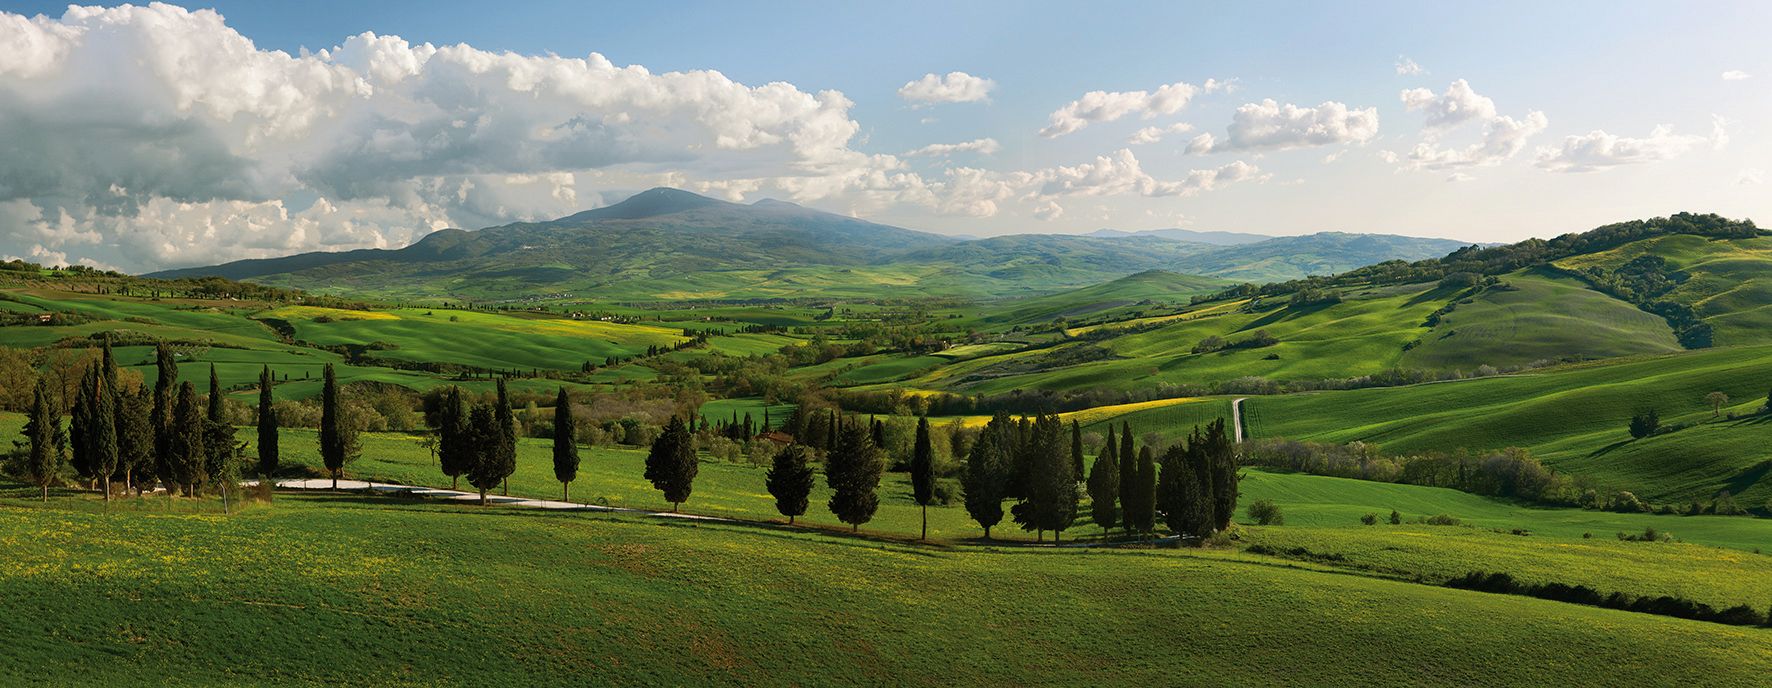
1187;99;1379;154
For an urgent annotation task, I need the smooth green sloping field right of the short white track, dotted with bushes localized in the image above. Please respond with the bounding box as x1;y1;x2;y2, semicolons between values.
1244;348;1772;505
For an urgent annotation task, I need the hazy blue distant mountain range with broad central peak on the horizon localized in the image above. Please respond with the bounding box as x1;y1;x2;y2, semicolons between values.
152;188;1462;301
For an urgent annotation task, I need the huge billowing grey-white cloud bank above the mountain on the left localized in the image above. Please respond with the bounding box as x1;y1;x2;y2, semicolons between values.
0;4;989;270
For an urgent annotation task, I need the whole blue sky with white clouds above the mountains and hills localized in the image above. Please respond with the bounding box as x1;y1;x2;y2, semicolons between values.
0;0;1772;271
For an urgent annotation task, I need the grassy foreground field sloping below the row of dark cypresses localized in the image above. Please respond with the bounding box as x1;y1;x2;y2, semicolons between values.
0;496;1772;686
